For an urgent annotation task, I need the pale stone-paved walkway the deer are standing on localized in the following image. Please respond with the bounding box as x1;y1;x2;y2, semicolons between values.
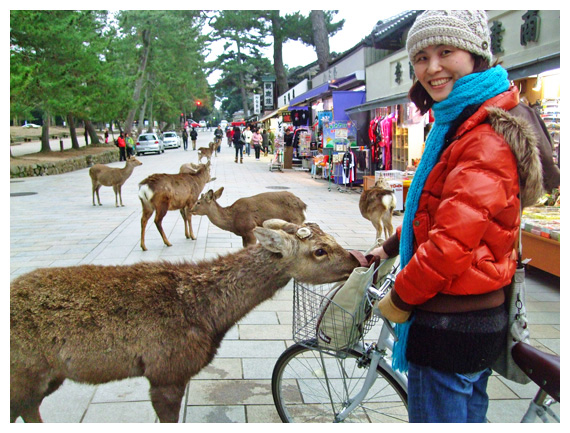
10;132;560;423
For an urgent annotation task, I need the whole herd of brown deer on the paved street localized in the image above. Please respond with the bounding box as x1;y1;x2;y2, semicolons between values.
10;143;395;422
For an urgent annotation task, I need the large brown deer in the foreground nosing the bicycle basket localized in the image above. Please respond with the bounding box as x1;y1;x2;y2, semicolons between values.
10;220;359;422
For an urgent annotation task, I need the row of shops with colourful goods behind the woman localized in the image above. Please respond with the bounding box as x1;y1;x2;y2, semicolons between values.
267;10;561;260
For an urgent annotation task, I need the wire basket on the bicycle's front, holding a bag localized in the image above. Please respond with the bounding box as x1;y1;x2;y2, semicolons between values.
293;280;379;357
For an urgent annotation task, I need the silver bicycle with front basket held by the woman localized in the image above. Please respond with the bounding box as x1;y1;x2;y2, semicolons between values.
271;259;560;423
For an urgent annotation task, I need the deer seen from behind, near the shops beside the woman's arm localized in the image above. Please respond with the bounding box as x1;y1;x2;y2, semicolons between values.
359;176;396;242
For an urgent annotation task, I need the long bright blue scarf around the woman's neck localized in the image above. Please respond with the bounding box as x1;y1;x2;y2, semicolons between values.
392;66;510;373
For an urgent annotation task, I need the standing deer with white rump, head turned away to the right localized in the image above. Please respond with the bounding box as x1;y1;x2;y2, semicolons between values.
139;162;214;251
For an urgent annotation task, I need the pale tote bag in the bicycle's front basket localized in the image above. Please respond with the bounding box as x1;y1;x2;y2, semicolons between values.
317;266;374;350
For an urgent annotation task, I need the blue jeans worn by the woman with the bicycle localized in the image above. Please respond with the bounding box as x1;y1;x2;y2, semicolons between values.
408;362;491;423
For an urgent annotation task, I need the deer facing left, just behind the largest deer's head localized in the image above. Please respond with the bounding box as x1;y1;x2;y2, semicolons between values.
191;187;307;247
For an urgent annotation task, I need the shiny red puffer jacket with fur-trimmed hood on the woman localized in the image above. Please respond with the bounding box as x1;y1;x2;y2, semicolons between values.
392;87;542;311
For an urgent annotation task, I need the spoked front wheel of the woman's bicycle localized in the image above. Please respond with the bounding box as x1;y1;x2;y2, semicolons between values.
271;343;408;423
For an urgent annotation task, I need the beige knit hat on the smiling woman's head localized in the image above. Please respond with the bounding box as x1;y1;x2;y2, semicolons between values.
406;11;493;63
